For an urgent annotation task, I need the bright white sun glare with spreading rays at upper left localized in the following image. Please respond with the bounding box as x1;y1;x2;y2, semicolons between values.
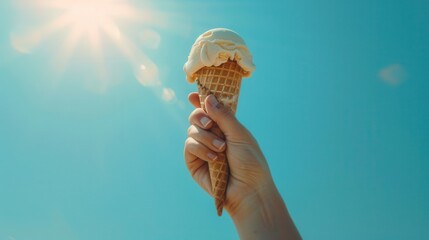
10;0;174;101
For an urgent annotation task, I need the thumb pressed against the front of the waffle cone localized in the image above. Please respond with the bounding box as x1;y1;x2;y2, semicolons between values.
205;95;247;139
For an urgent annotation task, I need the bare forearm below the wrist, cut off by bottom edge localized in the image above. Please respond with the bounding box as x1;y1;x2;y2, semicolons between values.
230;184;301;240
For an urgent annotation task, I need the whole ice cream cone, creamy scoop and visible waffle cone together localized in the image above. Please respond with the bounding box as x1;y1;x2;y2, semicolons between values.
183;28;255;216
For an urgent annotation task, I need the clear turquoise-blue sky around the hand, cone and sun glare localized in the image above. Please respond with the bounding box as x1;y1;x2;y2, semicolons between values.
0;0;429;240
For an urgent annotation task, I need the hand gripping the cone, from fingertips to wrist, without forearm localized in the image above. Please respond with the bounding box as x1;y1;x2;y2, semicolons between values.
185;93;272;214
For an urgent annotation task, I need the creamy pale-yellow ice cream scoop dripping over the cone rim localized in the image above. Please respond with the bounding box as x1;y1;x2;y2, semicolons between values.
183;28;255;83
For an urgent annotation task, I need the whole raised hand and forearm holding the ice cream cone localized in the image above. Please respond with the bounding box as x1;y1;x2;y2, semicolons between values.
185;93;300;239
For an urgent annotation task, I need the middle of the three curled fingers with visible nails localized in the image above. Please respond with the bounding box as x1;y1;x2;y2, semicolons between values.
188;125;226;152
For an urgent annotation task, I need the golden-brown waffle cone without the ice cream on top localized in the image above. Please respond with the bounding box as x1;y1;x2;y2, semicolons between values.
196;61;244;216
